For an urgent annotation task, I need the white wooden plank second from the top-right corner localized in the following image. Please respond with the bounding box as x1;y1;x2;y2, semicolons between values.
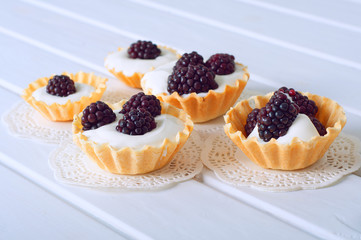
138;0;361;63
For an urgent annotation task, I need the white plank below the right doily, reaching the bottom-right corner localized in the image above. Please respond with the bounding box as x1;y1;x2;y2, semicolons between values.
203;170;361;239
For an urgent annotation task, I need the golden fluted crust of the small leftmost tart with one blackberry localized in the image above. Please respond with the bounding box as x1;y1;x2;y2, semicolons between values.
21;72;108;122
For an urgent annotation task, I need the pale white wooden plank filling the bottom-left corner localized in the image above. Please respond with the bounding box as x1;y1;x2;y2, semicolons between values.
0;162;125;240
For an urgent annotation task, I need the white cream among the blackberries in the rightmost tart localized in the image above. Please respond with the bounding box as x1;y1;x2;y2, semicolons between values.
247;114;320;144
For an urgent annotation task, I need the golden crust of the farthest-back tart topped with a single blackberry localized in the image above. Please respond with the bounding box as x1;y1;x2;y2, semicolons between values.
105;46;180;88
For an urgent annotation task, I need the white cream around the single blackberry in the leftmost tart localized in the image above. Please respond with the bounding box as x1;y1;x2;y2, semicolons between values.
33;82;95;105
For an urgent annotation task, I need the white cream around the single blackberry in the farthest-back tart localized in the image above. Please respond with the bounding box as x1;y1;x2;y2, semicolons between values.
104;47;177;77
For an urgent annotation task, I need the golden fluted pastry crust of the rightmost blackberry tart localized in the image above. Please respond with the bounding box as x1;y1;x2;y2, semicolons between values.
224;93;346;170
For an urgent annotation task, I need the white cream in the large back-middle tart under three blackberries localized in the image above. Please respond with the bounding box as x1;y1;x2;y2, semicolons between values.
142;61;244;98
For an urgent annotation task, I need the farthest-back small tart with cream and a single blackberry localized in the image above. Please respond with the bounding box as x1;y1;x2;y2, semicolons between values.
104;40;178;88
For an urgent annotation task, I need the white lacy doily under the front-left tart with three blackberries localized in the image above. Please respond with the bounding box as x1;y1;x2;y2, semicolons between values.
49;132;203;190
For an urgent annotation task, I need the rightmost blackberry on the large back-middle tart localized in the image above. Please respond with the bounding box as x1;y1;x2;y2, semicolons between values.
206;53;236;75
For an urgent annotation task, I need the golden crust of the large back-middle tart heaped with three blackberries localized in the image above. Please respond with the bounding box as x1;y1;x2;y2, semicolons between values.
143;63;249;122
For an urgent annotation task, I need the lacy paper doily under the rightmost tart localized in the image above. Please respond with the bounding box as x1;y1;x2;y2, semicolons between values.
201;132;361;192
